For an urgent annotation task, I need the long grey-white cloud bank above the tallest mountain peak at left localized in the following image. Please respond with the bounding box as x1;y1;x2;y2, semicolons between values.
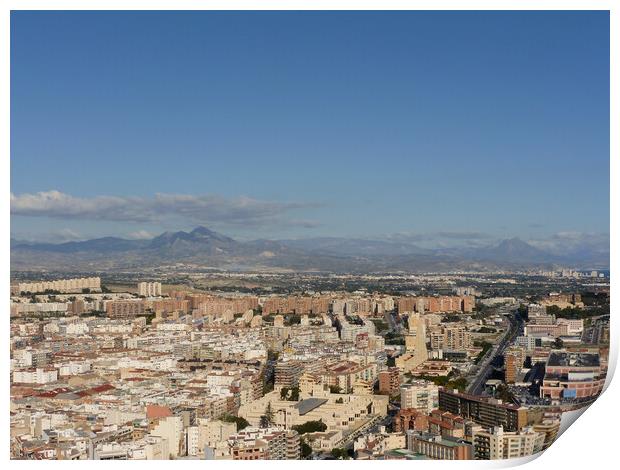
11;190;316;227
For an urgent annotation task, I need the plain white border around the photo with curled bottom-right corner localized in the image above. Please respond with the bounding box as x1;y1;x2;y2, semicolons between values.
0;0;620;469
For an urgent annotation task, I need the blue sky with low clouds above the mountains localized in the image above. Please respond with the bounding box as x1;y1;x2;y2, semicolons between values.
11;12;609;248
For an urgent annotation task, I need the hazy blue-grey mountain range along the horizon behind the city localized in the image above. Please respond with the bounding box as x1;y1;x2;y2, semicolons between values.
11;227;609;273
